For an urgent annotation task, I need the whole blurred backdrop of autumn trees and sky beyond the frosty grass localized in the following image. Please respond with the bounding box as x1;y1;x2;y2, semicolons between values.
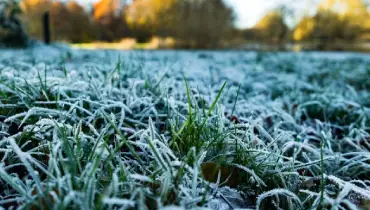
0;0;370;51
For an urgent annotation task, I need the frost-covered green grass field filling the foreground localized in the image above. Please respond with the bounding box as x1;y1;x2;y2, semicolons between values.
0;45;370;209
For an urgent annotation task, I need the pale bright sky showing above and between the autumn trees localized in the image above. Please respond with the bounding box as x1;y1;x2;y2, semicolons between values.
77;0;318;28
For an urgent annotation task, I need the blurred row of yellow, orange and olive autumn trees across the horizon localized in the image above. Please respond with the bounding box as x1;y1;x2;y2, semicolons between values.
5;0;370;48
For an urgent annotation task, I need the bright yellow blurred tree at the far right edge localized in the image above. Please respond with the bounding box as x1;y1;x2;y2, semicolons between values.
293;0;368;43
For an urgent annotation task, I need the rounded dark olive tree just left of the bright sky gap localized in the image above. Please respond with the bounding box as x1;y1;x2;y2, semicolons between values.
167;0;234;48
